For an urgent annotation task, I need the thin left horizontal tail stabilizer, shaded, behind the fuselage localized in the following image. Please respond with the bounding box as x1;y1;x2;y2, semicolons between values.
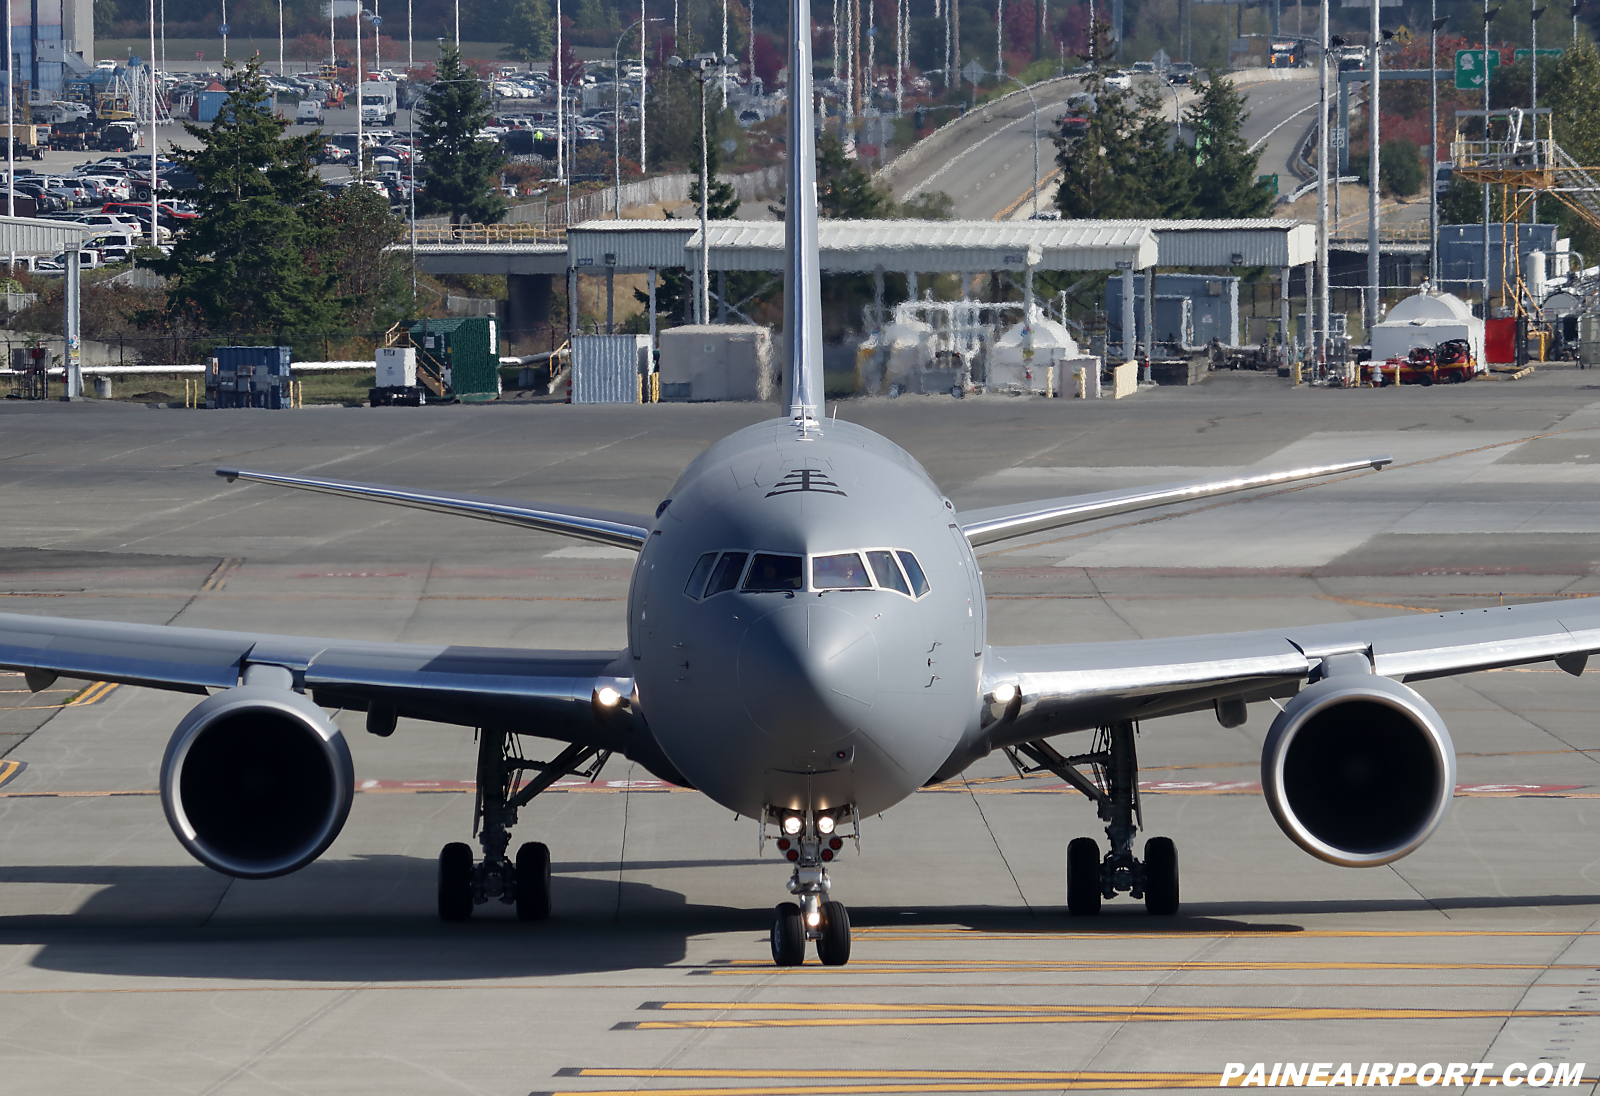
216;469;654;552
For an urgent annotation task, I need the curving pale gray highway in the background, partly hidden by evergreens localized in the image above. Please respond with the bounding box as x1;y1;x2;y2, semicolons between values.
885;69;1317;221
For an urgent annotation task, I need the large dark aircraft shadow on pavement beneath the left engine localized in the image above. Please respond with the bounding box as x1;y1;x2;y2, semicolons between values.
0;856;771;982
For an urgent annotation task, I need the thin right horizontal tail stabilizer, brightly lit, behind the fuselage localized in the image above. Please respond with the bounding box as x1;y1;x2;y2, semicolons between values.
957;456;1394;546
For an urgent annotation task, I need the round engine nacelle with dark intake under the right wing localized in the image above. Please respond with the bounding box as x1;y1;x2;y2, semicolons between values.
1261;674;1456;867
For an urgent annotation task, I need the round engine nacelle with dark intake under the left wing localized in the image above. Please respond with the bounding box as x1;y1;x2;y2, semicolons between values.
162;685;355;878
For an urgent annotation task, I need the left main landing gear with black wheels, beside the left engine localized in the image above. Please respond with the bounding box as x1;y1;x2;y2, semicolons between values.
438;728;611;922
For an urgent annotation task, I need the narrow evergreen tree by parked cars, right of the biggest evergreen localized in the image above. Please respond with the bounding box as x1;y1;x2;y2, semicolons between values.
416;43;506;224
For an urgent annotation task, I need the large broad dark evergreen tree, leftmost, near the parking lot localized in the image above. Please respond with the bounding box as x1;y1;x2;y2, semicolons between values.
150;61;339;339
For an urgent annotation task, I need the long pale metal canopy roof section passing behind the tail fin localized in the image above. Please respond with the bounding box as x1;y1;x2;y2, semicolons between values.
681;221;1157;274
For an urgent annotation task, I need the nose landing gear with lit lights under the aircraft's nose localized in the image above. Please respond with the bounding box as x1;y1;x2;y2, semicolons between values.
762;810;861;966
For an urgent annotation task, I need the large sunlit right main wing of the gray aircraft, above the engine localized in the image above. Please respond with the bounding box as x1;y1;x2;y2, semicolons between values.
984;598;1600;747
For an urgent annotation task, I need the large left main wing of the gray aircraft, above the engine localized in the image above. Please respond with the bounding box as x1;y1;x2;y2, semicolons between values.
0;613;632;749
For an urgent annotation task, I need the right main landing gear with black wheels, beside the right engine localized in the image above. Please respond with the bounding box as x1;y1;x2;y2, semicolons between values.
1006;720;1178;917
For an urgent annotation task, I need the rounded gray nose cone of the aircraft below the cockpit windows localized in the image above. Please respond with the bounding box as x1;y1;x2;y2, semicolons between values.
739;597;878;748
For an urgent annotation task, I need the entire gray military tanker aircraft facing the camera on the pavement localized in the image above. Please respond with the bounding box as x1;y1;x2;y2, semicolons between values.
0;0;1600;965
